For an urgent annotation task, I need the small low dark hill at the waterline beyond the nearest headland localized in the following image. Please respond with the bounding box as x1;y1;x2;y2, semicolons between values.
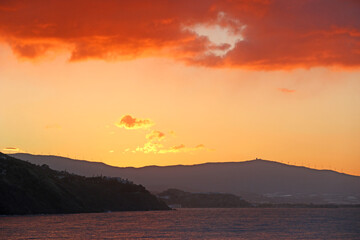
158;189;252;208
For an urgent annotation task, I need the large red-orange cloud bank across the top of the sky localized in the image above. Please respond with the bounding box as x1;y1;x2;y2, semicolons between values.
0;0;360;70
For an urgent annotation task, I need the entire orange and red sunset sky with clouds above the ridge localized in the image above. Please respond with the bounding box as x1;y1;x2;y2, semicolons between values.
0;0;360;175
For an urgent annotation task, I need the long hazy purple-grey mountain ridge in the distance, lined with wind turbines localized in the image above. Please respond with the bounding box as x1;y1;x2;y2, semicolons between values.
12;153;360;204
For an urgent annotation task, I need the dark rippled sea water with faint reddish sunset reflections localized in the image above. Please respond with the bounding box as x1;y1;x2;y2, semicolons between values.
0;208;360;239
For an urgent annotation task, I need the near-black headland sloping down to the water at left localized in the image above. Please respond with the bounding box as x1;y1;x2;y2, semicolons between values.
0;153;169;215
